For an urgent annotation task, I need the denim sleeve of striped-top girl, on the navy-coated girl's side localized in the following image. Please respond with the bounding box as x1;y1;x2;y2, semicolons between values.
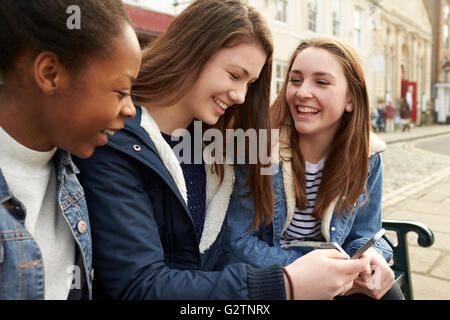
227;166;302;267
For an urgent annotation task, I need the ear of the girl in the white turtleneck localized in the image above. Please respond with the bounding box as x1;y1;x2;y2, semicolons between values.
34;51;66;95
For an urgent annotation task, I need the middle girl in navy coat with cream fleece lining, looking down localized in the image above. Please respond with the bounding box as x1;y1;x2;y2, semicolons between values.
77;0;368;299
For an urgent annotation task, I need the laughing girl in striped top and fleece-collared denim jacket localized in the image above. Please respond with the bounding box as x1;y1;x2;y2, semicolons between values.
228;38;402;299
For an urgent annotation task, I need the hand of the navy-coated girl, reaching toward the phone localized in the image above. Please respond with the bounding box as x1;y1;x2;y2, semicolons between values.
286;249;370;300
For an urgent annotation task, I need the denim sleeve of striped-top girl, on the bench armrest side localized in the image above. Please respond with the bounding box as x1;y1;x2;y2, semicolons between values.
343;154;392;262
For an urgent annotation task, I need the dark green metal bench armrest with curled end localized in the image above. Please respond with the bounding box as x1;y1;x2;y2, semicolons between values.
383;220;434;300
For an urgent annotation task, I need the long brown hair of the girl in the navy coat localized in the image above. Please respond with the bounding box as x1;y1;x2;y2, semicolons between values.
132;0;273;230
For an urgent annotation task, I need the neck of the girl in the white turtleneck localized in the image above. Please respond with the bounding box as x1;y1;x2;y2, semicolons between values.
0;87;54;151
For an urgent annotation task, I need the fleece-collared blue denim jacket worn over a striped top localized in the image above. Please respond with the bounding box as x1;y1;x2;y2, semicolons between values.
227;139;392;267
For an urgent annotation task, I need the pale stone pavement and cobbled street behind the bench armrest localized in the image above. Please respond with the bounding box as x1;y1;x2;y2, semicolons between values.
378;125;450;300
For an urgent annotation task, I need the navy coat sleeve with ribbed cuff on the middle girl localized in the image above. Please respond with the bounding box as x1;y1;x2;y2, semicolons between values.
77;146;285;300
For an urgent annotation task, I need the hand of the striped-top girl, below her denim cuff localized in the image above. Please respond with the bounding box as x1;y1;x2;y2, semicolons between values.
345;248;395;300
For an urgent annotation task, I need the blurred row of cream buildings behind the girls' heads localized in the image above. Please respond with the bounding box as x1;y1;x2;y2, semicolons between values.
0;0;450;125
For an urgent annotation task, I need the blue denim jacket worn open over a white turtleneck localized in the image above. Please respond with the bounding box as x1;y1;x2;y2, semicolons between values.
0;150;92;300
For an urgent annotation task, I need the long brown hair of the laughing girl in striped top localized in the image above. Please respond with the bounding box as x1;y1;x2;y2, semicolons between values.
272;38;370;218
